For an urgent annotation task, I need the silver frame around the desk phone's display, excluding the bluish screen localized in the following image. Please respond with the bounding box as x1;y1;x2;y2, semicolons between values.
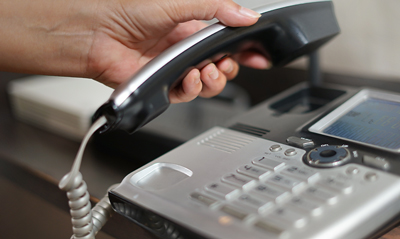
308;89;400;153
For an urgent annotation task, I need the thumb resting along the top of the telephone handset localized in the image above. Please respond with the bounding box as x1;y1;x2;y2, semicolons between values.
169;0;261;27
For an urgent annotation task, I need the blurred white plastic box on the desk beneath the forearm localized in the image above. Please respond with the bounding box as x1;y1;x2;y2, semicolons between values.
8;76;113;141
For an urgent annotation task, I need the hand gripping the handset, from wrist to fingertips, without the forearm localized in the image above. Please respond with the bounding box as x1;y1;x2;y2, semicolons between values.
89;0;267;103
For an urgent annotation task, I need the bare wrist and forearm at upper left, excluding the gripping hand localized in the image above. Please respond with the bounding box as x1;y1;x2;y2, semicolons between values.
0;0;97;76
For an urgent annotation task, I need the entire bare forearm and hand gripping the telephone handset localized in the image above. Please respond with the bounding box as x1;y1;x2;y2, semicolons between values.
0;0;268;103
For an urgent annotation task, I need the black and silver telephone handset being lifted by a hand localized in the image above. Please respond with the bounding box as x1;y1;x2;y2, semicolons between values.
94;0;340;133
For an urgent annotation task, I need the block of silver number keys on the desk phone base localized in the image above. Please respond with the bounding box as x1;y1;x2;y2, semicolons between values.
191;151;354;238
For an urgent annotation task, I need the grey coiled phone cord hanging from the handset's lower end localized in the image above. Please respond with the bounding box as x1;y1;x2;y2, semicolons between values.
58;116;113;239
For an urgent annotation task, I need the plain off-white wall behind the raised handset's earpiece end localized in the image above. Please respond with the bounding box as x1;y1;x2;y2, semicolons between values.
236;0;400;81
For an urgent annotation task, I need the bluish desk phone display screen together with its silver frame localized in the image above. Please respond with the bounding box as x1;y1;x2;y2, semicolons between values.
309;90;400;153
